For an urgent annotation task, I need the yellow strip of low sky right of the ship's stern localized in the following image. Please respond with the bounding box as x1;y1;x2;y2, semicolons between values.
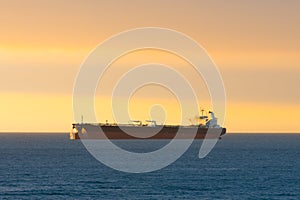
225;102;300;133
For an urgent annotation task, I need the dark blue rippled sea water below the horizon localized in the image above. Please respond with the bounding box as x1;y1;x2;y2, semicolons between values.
0;134;300;199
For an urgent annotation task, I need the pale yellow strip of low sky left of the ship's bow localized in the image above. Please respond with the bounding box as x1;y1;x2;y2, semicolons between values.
0;93;73;132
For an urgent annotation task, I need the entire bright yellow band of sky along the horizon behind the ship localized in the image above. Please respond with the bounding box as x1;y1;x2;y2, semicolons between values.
0;94;300;133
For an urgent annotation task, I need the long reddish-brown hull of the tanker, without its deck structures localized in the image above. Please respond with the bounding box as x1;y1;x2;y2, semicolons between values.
70;124;226;140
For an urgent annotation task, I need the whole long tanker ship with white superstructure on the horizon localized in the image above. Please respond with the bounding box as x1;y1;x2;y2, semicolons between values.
70;110;226;140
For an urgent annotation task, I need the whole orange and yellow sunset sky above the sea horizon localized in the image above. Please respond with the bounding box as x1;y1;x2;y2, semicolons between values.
0;0;300;133
